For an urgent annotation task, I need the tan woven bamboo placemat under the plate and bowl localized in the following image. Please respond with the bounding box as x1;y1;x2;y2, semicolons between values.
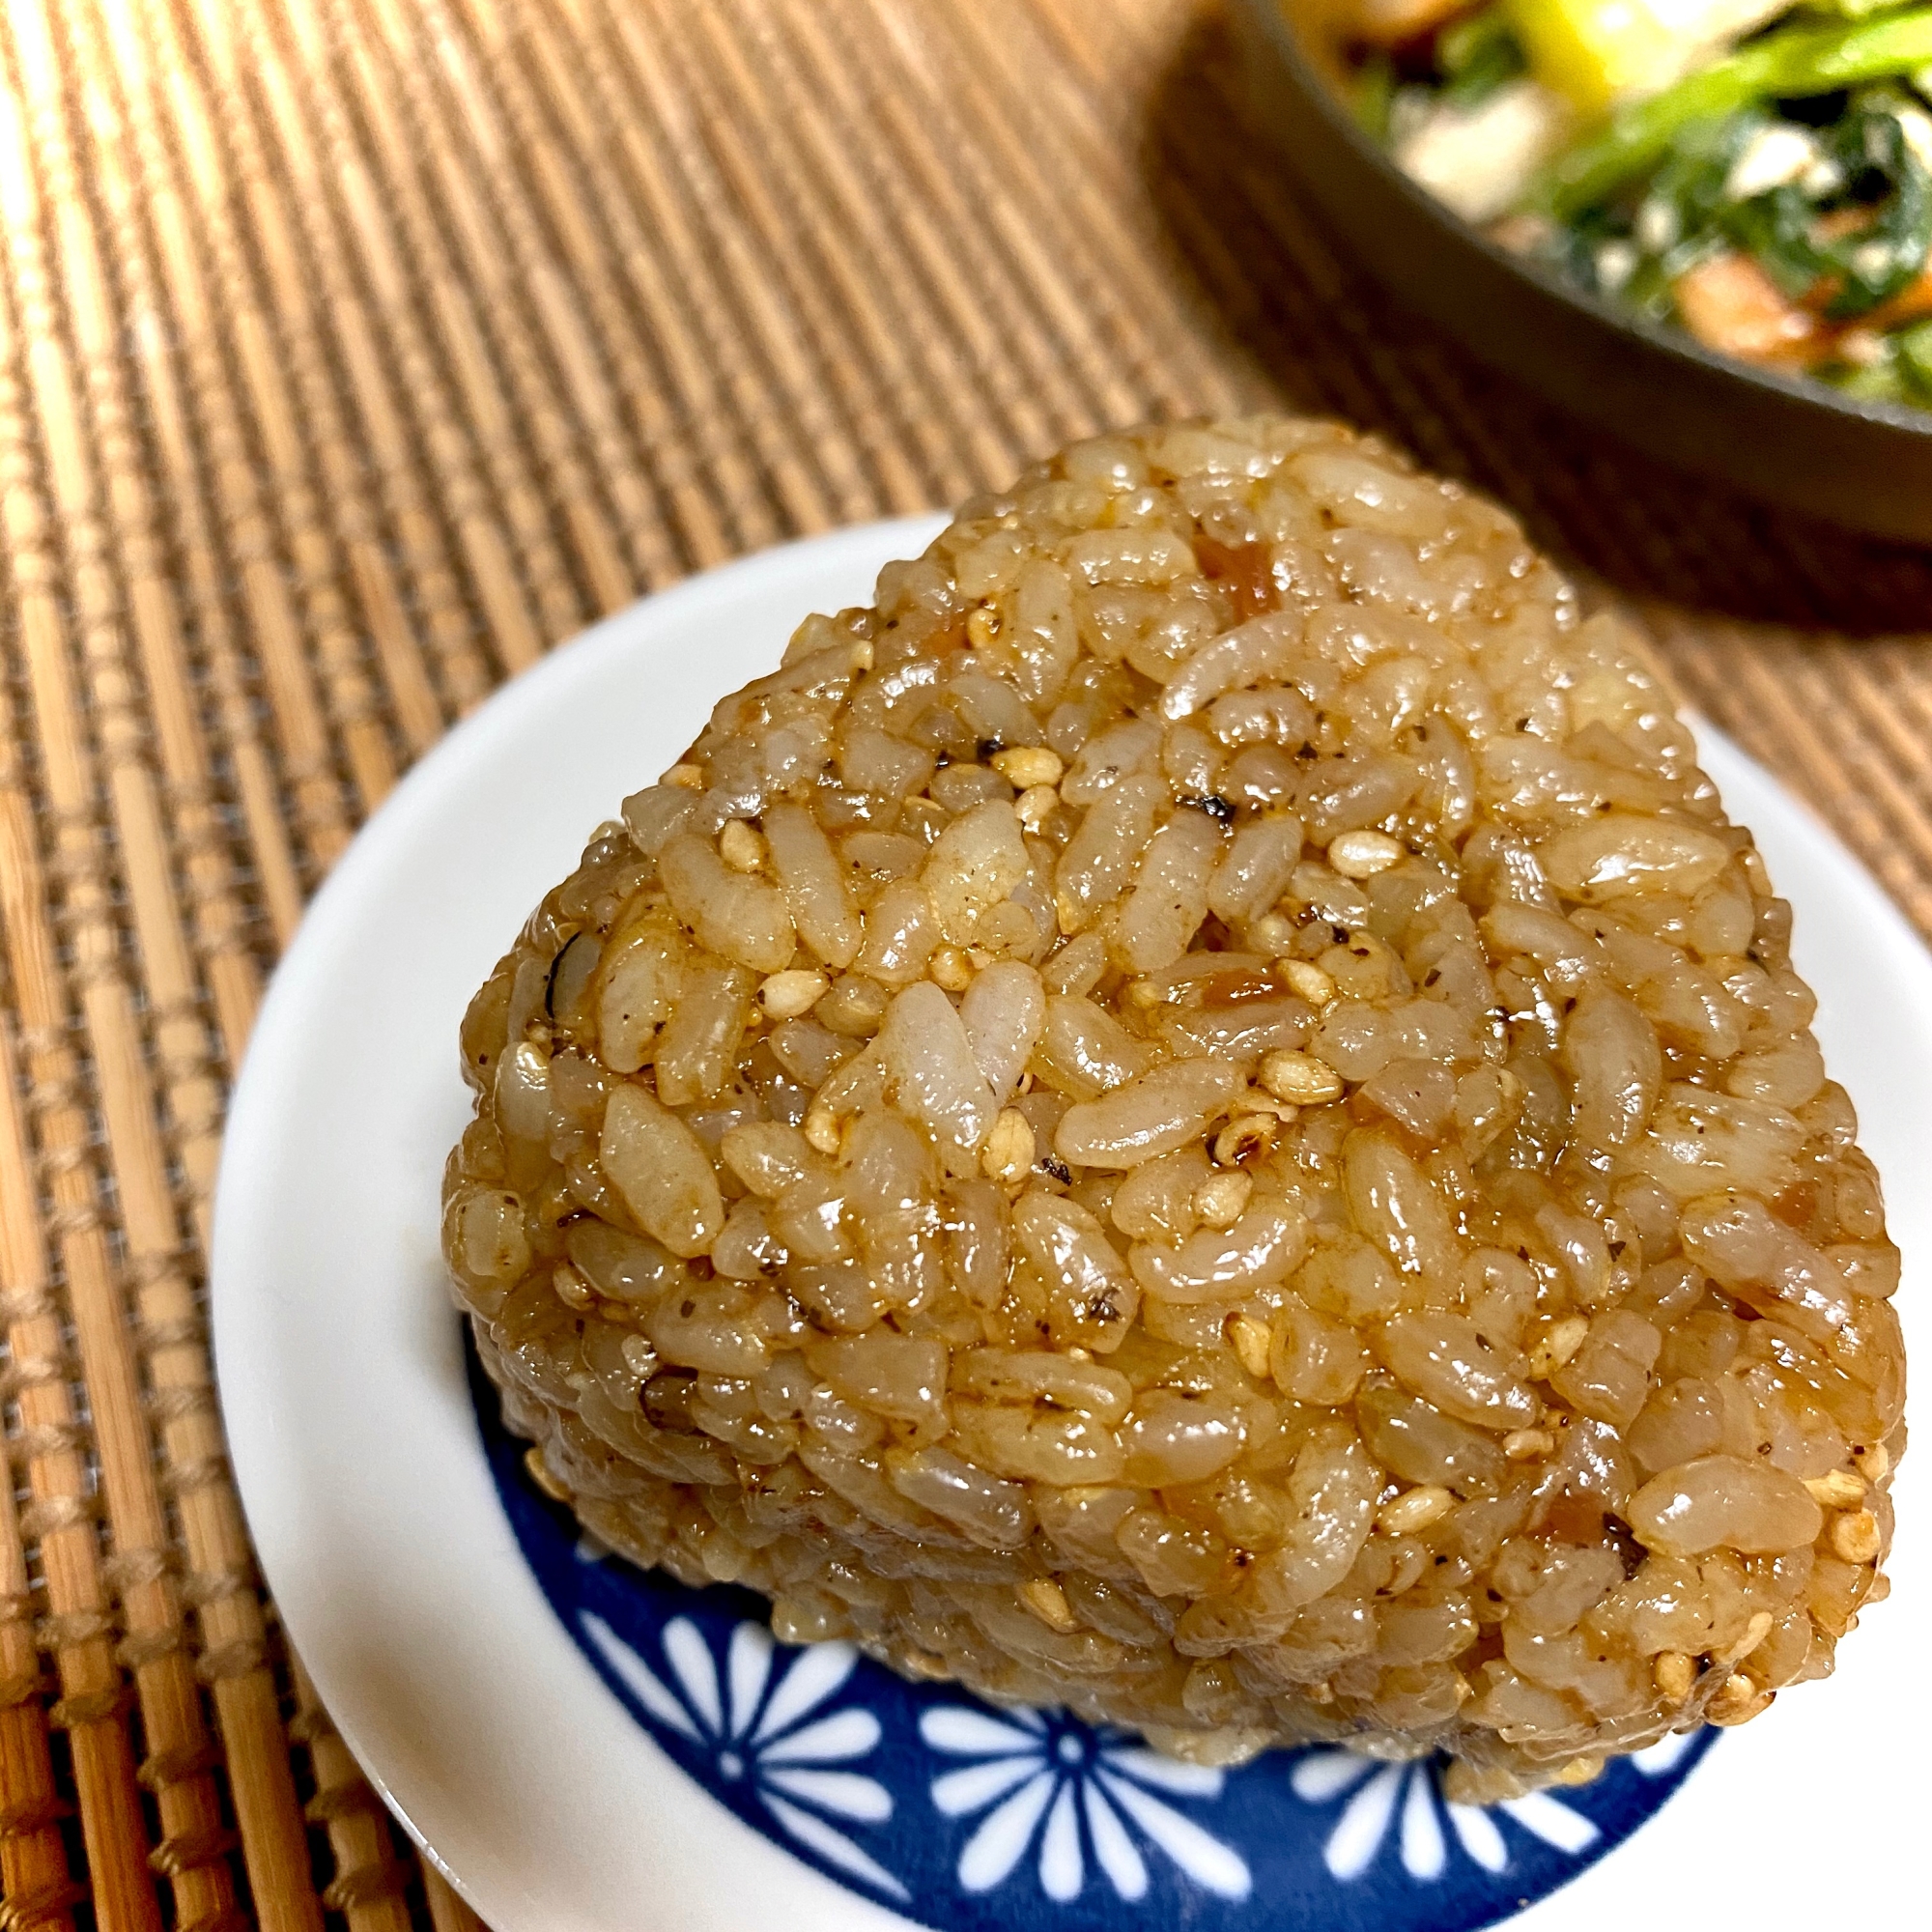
0;0;1932;1932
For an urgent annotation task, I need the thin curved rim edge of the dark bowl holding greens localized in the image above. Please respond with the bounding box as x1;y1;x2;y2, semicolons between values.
1238;0;1932;440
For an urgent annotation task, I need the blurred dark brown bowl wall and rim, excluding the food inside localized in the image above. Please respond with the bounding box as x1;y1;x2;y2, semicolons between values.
1233;0;1932;543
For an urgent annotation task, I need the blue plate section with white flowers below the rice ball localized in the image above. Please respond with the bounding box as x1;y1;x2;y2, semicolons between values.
471;1358;1712;1932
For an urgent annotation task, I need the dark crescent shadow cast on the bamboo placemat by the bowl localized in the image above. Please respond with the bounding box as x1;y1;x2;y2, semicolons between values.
1144;17;1932;636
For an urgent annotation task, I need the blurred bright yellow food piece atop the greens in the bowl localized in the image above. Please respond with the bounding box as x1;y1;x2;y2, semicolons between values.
1507;0;1789;114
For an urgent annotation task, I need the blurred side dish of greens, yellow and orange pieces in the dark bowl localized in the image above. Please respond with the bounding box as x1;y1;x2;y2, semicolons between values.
1291;0;1932;408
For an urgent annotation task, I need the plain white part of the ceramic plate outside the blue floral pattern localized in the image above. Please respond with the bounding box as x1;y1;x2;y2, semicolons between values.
214;520;1932;1932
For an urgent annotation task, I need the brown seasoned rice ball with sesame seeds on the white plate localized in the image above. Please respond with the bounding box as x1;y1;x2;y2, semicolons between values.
444;419;1905;1797
